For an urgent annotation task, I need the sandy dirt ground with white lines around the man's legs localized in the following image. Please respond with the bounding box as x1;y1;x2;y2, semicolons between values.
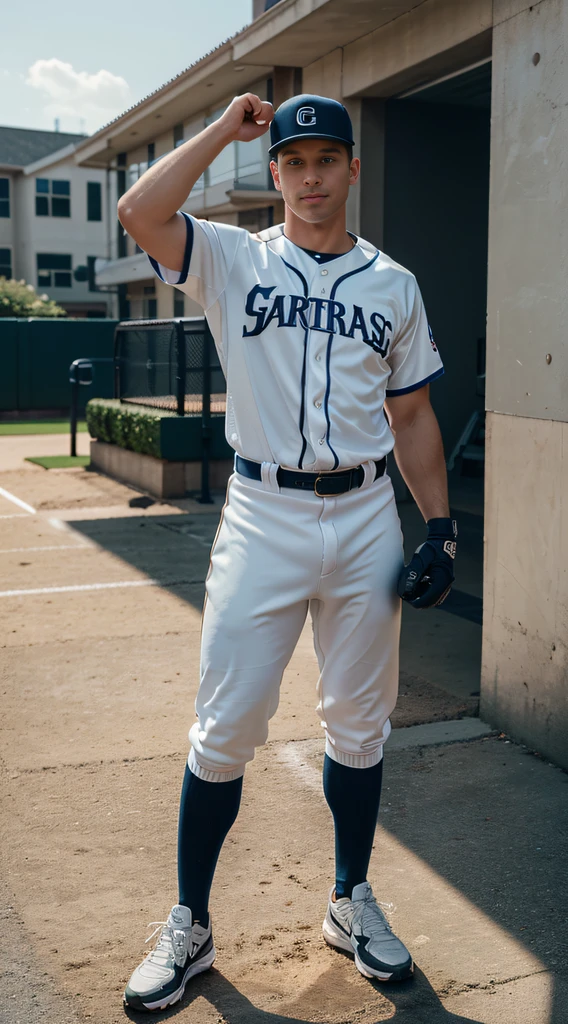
0;452;562;1024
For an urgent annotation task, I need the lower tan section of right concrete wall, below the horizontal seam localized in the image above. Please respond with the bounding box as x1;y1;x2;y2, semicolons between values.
481;413;568;768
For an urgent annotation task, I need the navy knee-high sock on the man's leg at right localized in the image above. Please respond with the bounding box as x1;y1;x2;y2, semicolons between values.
323;755;383;899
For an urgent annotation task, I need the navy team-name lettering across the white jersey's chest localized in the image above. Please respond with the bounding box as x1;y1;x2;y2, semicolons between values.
243;285;392;356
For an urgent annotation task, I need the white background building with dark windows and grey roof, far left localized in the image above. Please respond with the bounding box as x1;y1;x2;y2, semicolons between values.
0;128;116;316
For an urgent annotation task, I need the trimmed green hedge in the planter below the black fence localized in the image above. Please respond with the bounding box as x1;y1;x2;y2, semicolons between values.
86;398;172;459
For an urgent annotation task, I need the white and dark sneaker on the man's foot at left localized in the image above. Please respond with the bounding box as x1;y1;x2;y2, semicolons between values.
124;905;215;1010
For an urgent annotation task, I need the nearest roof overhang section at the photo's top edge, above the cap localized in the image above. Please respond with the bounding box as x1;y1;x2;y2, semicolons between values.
233;0;424;68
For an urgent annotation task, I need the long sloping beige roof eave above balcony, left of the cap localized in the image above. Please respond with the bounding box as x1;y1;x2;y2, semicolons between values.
75;42;272;167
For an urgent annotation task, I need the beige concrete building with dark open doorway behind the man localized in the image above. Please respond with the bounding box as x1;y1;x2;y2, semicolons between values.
76;0;568;766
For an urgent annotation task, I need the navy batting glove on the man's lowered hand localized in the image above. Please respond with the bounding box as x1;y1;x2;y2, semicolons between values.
397;519;457;608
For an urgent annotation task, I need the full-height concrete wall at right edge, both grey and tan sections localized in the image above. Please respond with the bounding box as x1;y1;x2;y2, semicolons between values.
481;0;568;767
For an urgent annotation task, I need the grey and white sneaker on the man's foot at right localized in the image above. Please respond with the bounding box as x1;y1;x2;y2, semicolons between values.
322;882;414;981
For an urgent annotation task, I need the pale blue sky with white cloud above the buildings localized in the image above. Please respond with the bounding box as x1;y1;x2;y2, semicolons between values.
0;0;253;134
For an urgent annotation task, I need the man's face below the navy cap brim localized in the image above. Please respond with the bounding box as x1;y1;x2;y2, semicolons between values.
270;138;359;224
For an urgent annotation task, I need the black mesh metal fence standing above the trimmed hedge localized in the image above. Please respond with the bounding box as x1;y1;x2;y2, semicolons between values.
115;316;226;416
